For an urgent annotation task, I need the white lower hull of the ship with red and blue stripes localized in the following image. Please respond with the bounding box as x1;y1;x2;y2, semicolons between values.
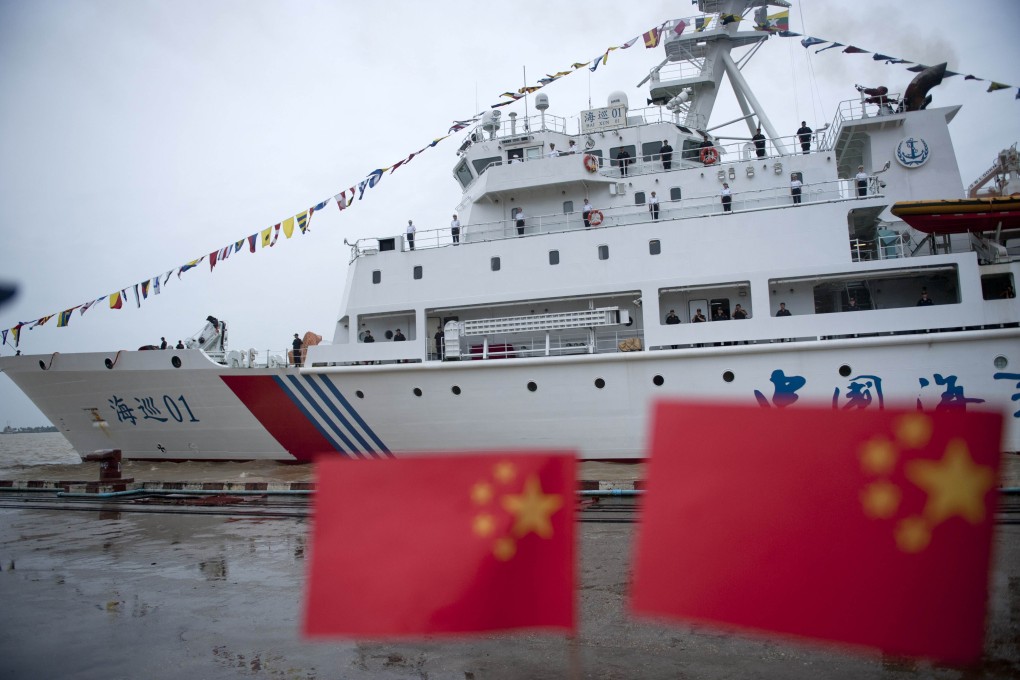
0;328;1020;462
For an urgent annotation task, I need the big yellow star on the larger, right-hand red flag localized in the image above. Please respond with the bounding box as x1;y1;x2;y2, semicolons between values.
906;439;995;527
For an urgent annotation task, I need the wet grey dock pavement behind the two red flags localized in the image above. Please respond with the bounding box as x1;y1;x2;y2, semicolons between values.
0;492;1020;680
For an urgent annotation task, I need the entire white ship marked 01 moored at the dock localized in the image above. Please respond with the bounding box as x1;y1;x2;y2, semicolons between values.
0;0;1020;461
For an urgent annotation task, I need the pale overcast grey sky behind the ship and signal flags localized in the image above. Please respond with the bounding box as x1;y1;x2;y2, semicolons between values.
0;0;1020;427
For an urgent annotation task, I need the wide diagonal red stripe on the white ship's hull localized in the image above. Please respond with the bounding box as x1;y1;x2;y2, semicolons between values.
220;375;348;462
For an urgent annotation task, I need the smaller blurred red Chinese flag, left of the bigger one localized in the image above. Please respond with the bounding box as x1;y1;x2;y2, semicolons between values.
305;452;576;638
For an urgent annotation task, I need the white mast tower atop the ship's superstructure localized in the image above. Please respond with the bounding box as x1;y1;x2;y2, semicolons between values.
639;0;789;155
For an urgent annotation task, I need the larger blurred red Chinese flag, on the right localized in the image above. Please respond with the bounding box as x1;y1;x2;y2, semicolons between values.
631;402;1002;663
